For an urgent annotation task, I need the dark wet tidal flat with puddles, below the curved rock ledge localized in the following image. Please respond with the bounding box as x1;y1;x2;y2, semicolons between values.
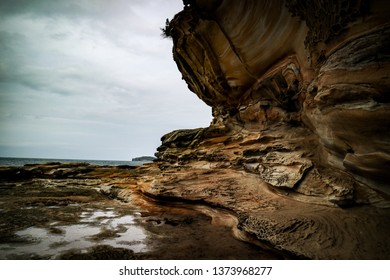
0;199;281;259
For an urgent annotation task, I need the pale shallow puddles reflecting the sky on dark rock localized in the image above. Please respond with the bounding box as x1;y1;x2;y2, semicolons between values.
0;209;147;259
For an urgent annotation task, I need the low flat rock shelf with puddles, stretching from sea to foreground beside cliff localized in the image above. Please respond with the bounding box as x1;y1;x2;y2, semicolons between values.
0;162;284;260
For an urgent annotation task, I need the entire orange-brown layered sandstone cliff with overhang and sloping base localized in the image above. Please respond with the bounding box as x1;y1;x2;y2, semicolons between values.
138;0;390;258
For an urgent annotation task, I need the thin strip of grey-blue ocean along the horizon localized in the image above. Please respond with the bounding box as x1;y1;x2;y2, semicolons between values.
0;157;150;166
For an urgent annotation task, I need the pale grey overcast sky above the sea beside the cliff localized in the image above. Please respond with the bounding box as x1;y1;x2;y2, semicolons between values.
0;0;211;160
